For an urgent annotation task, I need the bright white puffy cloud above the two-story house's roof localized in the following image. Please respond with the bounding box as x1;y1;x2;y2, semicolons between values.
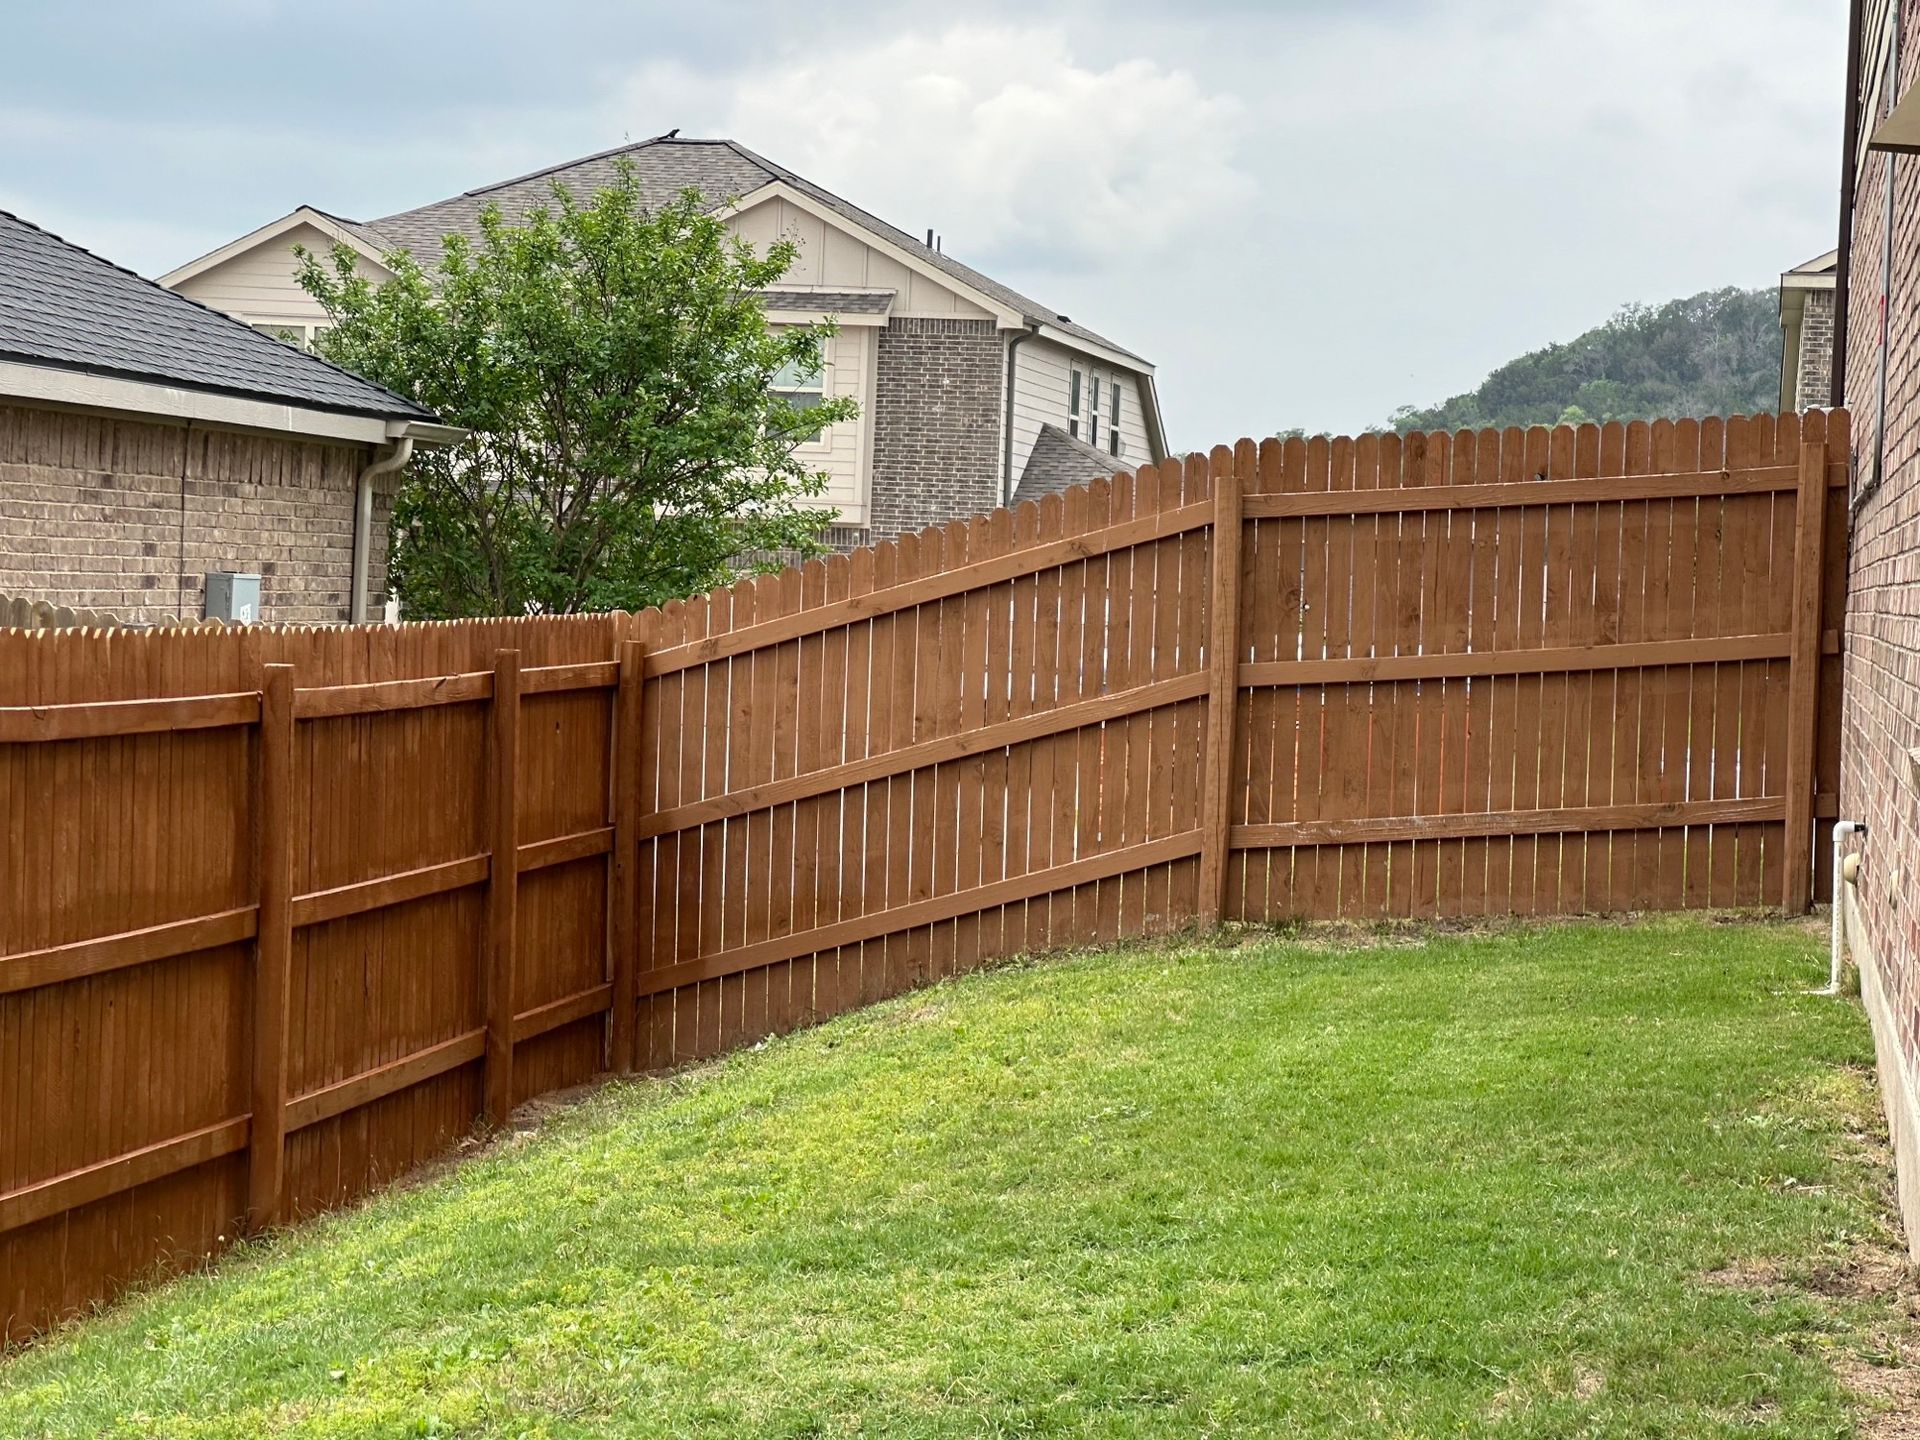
624;25;1254;269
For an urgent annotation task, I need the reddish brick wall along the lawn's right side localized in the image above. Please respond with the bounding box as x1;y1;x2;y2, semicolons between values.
1839;8;1920;1242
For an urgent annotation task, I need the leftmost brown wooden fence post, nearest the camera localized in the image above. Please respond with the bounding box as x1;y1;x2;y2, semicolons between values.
248;664;294;1231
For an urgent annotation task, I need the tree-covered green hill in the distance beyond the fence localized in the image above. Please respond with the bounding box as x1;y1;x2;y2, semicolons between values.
1382;286;1780;430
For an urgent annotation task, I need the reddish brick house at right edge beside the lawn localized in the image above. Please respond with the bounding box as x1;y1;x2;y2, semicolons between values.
1834;0;1920;1258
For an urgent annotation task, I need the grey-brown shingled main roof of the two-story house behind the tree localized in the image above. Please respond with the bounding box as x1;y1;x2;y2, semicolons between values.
343;134;1148;365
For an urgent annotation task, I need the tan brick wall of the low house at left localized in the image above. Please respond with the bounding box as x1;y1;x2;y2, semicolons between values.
0;405;394;624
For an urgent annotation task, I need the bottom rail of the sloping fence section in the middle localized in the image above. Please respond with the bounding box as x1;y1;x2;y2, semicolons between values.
641;831;1200;995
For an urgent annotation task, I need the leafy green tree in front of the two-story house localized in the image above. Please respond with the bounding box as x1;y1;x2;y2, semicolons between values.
300;167;854;618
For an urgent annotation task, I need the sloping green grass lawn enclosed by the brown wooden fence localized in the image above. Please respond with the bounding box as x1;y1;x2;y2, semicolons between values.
0;922;1907;1438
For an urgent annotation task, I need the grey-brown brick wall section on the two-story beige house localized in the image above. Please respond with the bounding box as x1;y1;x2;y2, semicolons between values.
870;319;1006;540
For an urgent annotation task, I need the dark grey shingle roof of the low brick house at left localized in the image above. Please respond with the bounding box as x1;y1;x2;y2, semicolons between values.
0;211;434;420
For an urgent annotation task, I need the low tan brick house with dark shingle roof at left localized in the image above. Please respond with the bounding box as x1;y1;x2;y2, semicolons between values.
0;211;459;622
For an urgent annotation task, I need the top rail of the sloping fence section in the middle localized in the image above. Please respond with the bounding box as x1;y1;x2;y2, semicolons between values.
647;505;1213;676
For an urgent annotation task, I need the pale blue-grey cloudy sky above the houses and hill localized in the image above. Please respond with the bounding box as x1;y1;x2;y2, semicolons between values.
0;0;1847;449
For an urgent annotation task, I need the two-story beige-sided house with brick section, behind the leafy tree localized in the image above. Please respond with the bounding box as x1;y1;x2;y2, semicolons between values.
159;134;1165;547
